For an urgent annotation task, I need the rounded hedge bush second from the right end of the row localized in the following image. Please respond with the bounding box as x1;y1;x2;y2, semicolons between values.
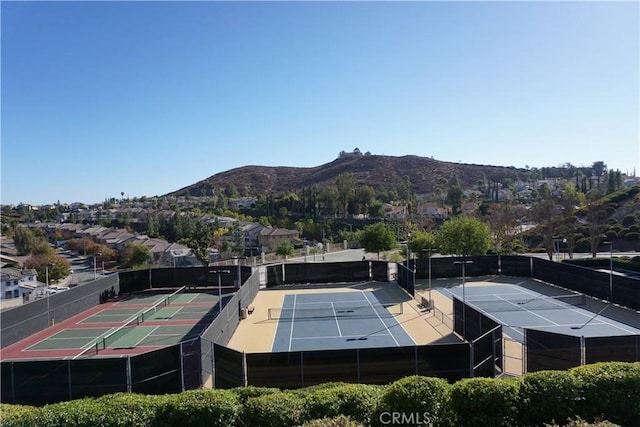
518;371;579;426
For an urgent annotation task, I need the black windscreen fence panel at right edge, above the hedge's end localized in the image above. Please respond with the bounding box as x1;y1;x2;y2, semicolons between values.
584;335;640;363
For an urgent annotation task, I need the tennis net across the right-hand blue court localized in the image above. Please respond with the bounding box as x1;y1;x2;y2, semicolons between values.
466;294;587;312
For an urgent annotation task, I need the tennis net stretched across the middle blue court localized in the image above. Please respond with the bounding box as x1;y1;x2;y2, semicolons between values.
268;302;404;320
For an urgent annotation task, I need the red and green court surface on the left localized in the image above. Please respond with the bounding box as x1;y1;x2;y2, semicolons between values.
3;287;224;360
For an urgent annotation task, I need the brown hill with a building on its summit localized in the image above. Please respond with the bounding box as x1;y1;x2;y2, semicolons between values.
167;152;529;196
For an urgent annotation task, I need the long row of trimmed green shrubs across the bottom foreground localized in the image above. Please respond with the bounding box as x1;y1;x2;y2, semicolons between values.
0;362;640;427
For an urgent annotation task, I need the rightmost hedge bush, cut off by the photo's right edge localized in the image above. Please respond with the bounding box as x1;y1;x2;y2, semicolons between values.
569;362;640;425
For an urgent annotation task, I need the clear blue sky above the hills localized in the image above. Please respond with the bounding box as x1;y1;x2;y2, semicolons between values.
0;1;640;204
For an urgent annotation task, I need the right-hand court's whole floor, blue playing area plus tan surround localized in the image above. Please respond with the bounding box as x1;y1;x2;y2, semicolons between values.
416;276;640;375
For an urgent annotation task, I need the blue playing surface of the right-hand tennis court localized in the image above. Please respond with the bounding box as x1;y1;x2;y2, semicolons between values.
439;285;640;341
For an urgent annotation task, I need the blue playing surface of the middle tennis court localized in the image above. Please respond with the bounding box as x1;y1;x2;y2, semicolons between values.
269;291;415;352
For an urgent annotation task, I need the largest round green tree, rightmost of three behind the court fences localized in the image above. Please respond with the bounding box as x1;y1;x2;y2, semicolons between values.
436;216;491;257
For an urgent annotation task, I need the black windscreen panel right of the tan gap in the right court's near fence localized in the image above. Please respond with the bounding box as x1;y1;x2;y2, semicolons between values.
524;329;582;372
